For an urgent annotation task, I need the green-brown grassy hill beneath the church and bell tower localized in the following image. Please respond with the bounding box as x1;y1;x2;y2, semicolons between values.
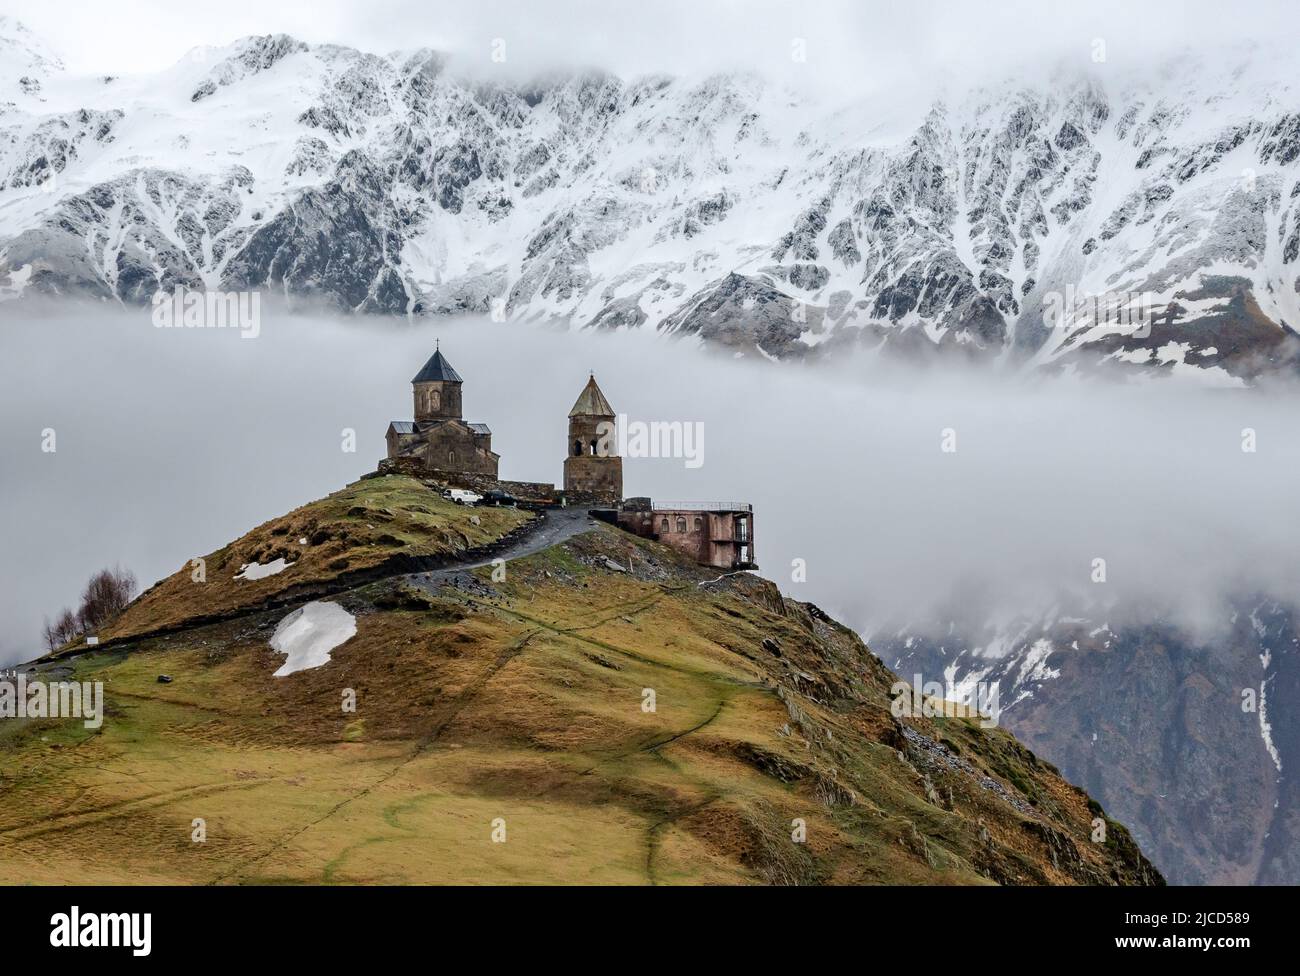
0;476;1160;884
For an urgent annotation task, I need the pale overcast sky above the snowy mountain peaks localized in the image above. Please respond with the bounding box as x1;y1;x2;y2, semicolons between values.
4;0;1300;88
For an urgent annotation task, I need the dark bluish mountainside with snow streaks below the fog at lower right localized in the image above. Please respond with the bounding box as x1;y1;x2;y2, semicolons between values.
872;599;1300;884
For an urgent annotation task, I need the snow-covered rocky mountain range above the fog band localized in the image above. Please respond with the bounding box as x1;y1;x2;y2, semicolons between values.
0;21;1300;383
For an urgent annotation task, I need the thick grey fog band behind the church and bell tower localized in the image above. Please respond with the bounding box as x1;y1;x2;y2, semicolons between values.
0;307;1300;664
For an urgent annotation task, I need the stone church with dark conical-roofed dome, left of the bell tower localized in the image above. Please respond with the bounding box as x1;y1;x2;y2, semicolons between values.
385;348;501;478
